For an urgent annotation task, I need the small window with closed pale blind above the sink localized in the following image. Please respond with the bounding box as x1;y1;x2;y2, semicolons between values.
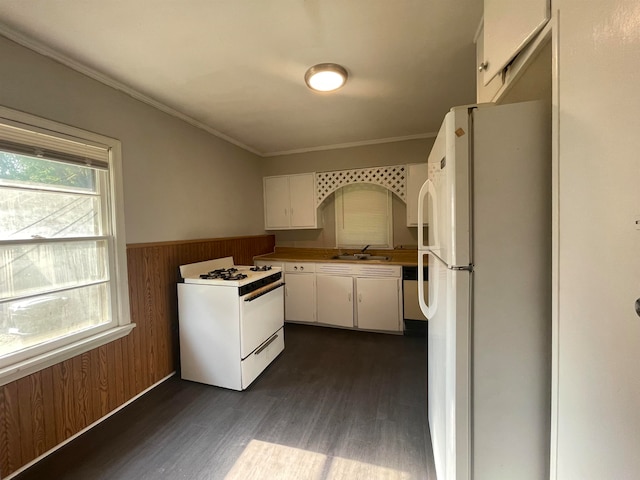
335;184;393;248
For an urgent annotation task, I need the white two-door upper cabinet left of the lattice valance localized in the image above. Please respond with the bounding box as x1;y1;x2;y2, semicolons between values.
263;173;318;230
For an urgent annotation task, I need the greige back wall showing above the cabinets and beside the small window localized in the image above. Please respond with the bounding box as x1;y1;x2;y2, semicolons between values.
262;137;435;248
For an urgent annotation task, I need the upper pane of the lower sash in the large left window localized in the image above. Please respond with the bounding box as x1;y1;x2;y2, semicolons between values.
0;240;108;300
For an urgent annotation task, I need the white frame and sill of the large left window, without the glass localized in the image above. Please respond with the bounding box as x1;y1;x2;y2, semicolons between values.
0;106;135;386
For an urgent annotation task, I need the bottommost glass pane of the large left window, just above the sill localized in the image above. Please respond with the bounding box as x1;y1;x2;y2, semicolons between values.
0;284;111;357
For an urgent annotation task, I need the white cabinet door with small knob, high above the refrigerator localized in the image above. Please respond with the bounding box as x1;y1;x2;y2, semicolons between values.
481;0;551;85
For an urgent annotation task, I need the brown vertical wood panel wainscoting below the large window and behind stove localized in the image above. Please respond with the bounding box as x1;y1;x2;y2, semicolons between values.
0;235;275;478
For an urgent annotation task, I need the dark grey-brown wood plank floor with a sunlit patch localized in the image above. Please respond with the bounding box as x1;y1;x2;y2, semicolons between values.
15;324;435;480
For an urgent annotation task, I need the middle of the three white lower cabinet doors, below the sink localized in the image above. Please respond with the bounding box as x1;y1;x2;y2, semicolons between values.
316;275;353;328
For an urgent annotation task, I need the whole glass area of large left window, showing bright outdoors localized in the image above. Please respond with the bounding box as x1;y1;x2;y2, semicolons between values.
0;152;110;357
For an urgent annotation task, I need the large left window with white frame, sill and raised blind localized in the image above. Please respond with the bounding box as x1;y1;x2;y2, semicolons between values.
0;108;133;384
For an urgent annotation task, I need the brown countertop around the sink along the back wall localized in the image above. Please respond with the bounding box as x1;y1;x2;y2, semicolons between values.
253;247;427;266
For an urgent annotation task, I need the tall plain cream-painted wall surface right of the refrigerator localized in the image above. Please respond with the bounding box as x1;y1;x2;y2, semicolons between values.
551;0;640;480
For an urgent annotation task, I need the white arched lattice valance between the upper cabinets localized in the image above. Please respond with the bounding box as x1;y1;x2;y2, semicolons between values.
316;165;407;206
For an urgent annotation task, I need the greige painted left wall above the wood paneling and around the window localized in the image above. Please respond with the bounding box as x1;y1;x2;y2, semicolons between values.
0;37;264;243
